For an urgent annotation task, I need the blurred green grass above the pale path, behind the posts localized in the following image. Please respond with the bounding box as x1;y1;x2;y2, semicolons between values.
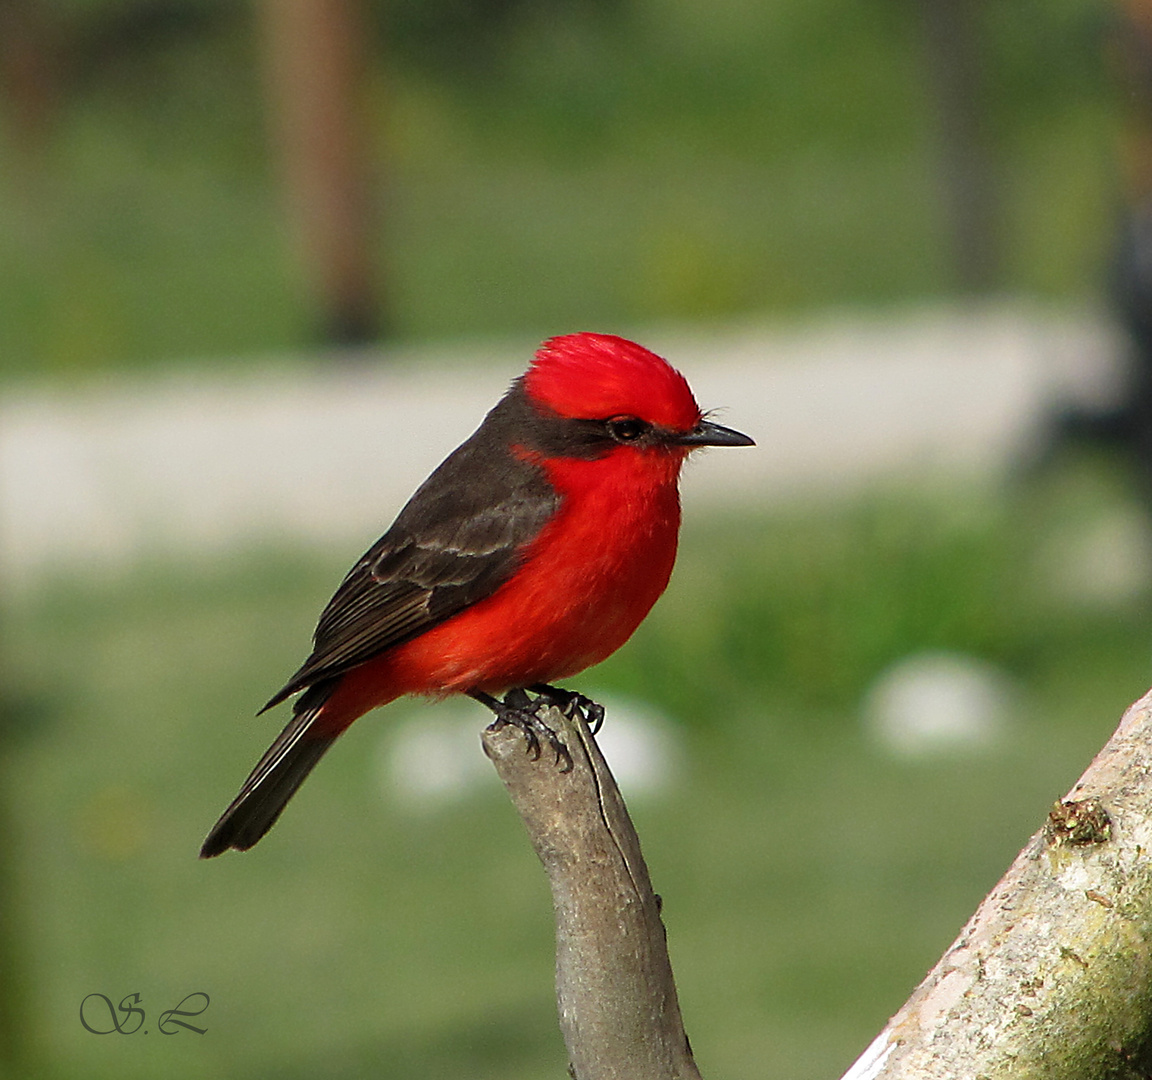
0;0;1121;378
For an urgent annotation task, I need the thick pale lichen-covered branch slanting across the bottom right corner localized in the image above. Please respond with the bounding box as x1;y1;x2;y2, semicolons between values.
843;691;1152;1080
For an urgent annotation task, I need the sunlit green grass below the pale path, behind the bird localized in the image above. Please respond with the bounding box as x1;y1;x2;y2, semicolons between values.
3;462;1152;1080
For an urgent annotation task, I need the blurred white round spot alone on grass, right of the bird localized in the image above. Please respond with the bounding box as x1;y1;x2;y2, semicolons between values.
864;653;1011;758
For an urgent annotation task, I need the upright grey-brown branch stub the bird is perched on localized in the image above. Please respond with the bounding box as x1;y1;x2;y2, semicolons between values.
483;708;699;1080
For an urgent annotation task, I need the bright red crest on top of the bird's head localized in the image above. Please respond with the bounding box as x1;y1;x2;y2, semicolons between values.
524;334;700;431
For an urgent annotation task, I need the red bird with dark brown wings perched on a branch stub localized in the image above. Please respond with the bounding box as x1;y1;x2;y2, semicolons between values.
200;334;752;858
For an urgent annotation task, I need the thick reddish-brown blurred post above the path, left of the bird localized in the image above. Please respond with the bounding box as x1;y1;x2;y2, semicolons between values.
259;0;385;344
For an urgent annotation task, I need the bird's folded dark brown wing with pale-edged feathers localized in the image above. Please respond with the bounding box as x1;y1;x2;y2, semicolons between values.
265;427;559;708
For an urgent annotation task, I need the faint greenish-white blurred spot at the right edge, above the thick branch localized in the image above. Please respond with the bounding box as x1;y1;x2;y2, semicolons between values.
1045;505;1152;607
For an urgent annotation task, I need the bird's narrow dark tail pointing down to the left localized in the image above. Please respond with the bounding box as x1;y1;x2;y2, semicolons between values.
200;679;339;859
